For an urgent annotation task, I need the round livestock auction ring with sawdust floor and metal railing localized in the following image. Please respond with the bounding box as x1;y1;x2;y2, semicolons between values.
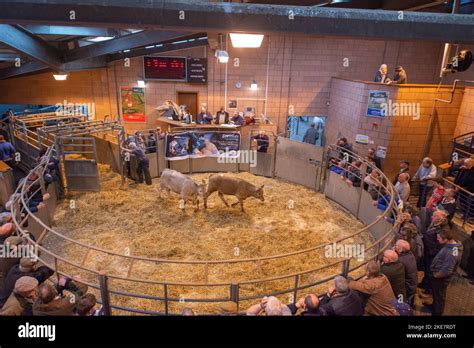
9;139;398;315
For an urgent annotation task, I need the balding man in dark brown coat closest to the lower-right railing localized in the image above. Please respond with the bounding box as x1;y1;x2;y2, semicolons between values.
380;250;407;302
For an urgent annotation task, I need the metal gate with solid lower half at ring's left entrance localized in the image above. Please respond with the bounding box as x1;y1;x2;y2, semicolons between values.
56;137;100;191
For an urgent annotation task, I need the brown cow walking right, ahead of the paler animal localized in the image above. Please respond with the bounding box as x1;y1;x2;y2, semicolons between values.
204;174;265;211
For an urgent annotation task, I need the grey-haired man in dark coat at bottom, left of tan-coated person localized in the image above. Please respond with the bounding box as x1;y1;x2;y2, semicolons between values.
319;276;364;316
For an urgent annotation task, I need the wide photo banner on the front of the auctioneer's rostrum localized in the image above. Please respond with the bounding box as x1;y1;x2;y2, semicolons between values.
165;131;240;161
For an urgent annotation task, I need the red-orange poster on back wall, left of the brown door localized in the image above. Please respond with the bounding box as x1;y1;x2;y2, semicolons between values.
120;87;146;123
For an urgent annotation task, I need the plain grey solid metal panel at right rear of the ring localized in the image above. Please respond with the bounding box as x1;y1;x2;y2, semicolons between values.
275;137;324;191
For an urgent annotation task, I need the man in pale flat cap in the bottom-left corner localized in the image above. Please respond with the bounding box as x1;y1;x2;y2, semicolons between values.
0;276;38;316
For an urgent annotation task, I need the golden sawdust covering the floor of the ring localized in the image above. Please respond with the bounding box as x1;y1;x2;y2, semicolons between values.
45;165;372;314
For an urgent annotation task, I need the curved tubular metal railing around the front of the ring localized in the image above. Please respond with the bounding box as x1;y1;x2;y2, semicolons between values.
12;143;399;315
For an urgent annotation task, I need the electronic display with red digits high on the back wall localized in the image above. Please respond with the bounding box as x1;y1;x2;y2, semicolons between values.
144;57;186;81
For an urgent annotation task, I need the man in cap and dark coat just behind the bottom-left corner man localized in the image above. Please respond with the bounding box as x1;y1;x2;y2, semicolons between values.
0;257;54;306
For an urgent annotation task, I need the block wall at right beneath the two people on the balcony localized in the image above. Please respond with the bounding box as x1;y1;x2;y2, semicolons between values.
326;78;469;175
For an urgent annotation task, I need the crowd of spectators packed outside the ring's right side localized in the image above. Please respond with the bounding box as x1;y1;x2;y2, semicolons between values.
329;138;474;315
